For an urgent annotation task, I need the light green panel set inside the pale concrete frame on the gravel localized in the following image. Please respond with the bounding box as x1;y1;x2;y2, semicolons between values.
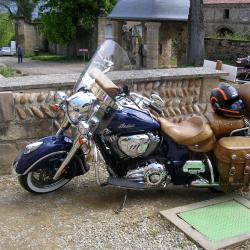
178;201;250;241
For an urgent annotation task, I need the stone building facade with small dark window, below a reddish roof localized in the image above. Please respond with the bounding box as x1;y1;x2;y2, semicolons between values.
204;0;250;36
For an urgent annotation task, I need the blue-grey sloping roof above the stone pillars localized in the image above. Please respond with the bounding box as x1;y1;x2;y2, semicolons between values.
109;0;190;21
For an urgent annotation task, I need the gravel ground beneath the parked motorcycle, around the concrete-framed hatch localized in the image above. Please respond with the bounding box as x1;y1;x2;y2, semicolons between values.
0;172;250;250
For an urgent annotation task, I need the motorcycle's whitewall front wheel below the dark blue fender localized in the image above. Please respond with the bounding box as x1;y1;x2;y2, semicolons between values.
18;168;70;194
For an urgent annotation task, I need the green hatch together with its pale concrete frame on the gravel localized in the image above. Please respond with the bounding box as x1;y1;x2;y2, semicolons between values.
160;196;250;250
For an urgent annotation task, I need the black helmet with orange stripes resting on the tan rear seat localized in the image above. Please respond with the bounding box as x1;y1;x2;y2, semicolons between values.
210;83;244;118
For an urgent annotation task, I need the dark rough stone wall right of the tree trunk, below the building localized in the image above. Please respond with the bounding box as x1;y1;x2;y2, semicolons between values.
205;38;250;61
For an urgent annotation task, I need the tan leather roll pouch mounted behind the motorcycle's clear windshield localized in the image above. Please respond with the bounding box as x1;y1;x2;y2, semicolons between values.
89;68;120;98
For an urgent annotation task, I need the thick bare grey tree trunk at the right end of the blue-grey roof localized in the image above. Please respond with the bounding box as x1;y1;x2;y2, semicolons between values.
187;0;205;66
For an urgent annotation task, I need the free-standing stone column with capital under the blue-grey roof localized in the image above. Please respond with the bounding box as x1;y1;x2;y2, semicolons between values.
145;22;161;68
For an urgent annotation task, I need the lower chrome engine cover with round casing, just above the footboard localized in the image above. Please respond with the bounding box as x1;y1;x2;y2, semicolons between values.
125;161;171;188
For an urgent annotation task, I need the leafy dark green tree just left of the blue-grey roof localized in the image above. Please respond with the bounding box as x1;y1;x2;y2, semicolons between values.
39;0;116;54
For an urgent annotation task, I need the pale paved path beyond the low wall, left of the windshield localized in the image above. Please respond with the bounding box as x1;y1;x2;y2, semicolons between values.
0;57;84;75
